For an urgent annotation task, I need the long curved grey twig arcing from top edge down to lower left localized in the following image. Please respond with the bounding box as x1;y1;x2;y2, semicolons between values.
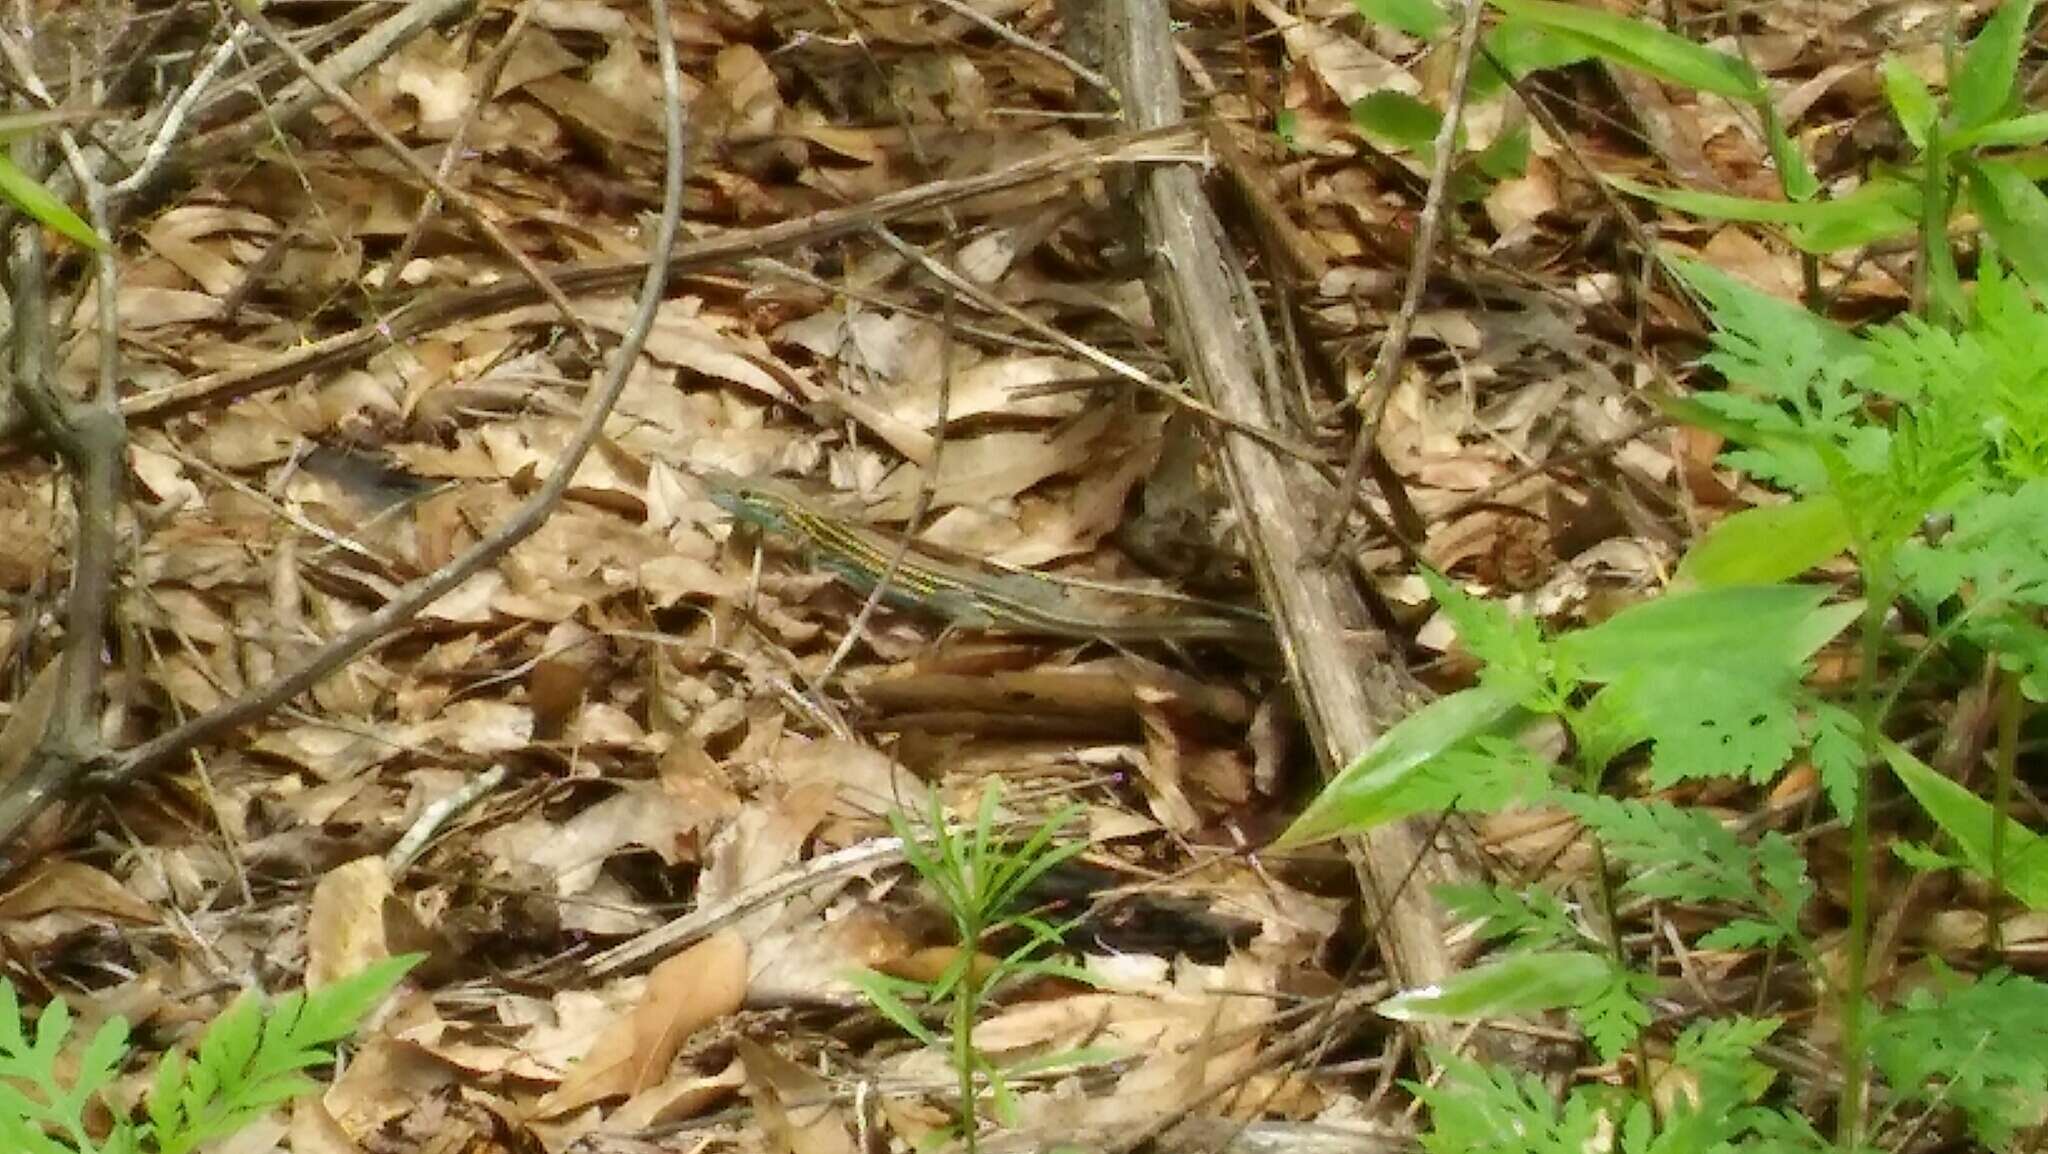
0;0;686;844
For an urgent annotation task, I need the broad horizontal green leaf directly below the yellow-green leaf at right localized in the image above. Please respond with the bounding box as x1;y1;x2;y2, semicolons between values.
1554;584;1829;681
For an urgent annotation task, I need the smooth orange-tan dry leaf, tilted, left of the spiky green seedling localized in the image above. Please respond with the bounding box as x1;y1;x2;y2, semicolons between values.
541;931;748;1117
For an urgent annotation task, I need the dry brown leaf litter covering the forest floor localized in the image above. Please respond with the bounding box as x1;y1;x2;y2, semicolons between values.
0;0;2007;1154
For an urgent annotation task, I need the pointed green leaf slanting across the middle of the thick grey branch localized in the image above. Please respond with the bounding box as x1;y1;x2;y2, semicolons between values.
1274;685;1528;849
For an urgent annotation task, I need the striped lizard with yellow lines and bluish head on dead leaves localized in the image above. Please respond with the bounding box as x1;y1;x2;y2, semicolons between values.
705;473;1272;644
